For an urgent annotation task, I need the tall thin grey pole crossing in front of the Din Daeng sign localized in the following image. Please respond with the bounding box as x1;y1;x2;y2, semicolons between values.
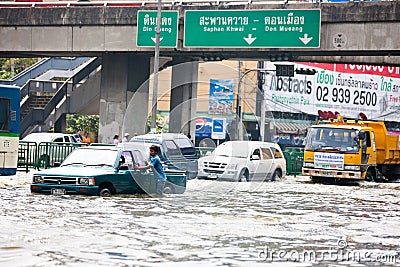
150;0;162;132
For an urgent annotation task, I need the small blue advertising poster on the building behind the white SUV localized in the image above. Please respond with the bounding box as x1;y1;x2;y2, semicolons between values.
208;79;235;114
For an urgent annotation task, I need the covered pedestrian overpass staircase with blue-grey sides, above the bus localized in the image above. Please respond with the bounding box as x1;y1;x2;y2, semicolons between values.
0;57;100;137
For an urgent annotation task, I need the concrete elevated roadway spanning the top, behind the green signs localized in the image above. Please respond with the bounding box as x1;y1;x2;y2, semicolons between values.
0;1;400;65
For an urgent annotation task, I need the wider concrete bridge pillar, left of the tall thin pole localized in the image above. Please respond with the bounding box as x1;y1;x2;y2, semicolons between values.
99;54;150;143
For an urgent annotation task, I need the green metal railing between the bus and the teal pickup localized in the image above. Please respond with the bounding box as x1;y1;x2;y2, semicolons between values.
18;141;86;172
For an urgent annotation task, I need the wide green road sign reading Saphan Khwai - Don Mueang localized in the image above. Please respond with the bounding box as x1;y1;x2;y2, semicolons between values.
183;9;321;48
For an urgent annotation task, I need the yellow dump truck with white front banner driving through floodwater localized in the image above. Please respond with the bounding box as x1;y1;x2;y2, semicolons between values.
302;116;400;182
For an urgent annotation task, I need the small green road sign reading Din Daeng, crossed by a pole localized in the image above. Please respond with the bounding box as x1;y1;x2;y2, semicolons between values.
136;11;178;47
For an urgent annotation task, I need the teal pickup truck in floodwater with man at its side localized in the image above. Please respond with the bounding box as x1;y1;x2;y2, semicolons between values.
30;146;186;196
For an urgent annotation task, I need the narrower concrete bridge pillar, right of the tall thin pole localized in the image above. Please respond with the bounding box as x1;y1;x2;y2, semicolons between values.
169;62;199;140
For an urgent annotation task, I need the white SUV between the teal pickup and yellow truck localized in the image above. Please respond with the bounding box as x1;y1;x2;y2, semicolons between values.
197;141;286;182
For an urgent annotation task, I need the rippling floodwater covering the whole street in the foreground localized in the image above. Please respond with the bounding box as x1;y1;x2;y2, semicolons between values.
0;173;400;266
